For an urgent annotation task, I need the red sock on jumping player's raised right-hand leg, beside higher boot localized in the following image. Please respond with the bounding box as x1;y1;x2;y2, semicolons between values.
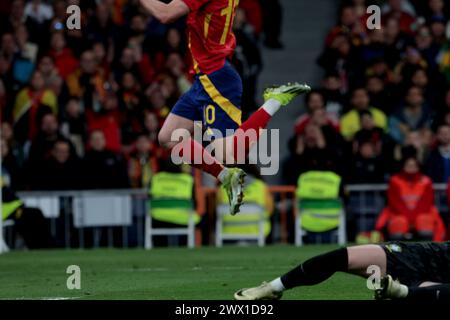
233;108;272;161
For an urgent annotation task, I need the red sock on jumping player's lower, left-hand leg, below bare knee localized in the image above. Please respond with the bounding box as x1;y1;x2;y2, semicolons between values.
178;138;224;178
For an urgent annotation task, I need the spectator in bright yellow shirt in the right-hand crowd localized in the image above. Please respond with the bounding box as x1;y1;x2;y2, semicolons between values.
341;88;387;140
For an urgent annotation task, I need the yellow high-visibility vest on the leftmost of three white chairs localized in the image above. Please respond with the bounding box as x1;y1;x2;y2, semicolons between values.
149;172;200;225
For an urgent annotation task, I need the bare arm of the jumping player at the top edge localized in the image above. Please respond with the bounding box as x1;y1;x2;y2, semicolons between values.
140;0;189;24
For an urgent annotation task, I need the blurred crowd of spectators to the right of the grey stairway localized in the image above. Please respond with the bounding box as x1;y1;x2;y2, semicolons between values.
283;0;450;184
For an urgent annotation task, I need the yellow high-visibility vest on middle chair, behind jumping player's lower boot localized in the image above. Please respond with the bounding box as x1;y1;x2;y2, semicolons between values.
218;179;271;236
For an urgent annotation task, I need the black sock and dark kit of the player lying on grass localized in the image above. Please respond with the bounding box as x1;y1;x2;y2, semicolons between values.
281;242;450;299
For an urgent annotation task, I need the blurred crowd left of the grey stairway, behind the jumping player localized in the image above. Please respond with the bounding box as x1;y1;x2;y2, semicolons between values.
0;0;282;190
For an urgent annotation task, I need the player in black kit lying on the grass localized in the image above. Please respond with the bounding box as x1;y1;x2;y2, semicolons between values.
234;242;450;300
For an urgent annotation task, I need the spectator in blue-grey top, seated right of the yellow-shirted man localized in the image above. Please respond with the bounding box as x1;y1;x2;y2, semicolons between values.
389;86;432;144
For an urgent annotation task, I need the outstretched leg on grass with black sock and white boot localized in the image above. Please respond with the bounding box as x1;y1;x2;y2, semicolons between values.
235;245;386;300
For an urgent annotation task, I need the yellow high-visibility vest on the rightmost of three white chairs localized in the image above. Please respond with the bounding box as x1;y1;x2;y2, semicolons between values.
296;171;342;232
